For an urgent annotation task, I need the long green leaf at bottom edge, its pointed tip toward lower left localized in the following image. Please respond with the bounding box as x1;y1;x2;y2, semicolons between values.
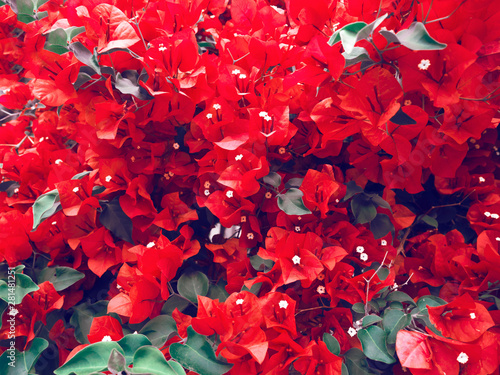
54;341;124;375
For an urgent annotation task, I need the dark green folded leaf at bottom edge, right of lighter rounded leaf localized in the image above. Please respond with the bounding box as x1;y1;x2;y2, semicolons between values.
170;326;232;375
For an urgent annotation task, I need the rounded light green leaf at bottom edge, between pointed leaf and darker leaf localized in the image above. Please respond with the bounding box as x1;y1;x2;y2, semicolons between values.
133;346;186;375
